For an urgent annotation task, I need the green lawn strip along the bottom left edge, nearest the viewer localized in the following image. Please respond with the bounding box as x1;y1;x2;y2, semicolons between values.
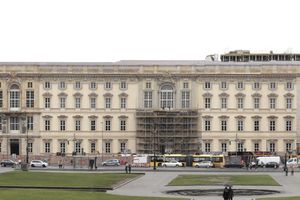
0;189;186;200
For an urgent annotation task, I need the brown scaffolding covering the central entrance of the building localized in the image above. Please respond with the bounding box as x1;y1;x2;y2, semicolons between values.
136;110;200;154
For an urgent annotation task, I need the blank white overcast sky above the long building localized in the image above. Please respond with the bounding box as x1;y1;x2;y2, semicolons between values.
0;0;300;62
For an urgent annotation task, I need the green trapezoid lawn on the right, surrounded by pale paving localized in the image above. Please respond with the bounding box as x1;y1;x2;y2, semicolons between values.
169;175;279;186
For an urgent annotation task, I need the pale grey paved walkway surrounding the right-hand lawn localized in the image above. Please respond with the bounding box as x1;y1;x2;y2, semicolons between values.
108;172;300;200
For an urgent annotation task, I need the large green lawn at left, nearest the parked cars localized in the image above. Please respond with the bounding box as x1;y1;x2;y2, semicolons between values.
0;171;141;187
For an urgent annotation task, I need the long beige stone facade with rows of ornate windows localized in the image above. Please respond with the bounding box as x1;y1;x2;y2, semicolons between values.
0;61;300;160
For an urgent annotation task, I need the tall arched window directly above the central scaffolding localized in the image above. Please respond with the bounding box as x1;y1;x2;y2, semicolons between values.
160;85;174;108
